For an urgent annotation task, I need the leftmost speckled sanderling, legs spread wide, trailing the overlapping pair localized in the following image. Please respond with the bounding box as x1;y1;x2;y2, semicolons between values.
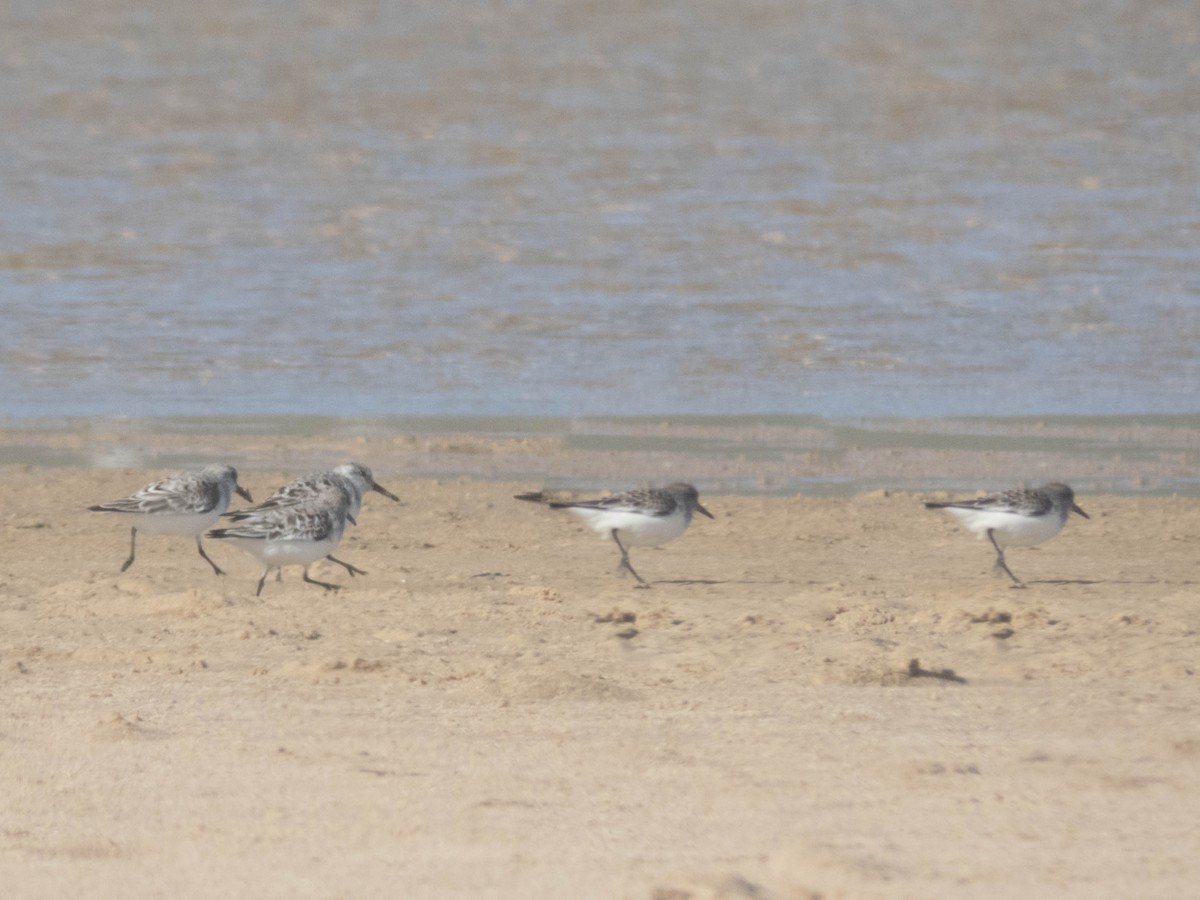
88;464;251;575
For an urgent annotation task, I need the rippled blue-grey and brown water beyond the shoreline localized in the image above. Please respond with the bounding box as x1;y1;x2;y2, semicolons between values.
0;0;1200;416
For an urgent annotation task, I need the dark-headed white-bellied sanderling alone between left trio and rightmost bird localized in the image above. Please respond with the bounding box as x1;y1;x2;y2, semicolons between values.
515;482;713;588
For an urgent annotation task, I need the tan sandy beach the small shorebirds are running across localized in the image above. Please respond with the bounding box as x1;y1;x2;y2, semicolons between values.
0;467;1200;900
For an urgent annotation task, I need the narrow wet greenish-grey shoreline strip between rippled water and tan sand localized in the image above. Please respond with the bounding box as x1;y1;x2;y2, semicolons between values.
0;415;1200;497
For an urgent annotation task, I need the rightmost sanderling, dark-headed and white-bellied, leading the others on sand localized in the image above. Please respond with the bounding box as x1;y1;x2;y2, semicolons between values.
925;482;1090;587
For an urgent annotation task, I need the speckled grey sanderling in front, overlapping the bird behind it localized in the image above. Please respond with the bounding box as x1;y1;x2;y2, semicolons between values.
208;484;352;596
